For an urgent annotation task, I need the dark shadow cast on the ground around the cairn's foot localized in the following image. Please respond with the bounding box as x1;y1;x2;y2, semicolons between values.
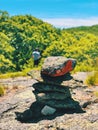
15;100;85;123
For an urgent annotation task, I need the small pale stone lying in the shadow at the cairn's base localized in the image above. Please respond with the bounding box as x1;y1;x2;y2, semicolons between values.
41;105;56;116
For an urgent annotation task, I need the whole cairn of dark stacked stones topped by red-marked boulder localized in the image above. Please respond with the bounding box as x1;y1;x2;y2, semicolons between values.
33;56;79;113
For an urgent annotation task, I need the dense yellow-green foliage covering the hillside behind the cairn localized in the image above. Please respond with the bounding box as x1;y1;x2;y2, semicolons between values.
0;11;98;73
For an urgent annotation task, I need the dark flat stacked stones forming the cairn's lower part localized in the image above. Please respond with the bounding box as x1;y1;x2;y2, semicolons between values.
33;82;78;114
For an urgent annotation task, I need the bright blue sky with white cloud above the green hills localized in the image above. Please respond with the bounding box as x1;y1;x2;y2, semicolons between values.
0;0;98;28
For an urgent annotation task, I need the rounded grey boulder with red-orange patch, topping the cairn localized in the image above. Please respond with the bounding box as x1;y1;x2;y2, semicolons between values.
41;56;76;77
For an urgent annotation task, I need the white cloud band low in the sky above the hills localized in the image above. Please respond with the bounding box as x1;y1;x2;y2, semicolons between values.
43;17;98;28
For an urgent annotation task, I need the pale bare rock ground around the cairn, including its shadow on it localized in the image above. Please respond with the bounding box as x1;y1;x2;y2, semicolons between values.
0;74;98;130
